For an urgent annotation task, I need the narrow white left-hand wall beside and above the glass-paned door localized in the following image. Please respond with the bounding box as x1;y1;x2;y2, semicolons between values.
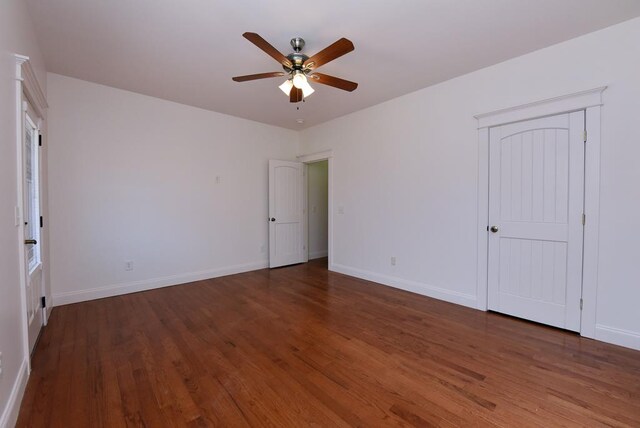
0;0;45;427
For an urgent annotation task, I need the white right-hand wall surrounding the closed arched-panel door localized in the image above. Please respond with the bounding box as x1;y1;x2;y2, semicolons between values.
301;19;640;349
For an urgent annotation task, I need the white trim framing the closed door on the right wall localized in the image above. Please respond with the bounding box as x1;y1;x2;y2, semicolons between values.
474;86;607;338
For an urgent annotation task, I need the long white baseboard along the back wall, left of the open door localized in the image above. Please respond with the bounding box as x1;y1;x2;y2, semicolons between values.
52;260;269;306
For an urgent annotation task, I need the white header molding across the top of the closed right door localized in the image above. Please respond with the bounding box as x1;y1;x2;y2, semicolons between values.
474;86;607;129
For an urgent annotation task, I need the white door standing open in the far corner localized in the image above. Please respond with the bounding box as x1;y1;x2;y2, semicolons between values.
269;160;305;268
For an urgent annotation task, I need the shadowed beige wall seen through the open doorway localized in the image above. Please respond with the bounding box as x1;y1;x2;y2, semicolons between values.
307;160;329;260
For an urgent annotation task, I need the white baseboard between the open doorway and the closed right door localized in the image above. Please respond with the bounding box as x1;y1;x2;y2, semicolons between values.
329;263;477;309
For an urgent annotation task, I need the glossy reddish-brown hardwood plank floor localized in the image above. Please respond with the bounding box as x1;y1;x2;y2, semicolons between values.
18;259;640;427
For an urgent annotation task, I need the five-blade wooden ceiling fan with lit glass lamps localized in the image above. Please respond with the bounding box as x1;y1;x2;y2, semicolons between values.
233;33;358;103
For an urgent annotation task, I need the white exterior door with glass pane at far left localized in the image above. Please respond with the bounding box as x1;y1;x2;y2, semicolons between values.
22;103;43;352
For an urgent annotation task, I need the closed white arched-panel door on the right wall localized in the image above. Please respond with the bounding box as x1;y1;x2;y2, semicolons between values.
488;111;585;331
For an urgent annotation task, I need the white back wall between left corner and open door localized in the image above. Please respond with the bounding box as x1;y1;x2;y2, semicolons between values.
48;74;298;305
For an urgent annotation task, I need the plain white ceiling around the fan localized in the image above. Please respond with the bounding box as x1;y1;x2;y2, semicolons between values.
28;0;640;129
